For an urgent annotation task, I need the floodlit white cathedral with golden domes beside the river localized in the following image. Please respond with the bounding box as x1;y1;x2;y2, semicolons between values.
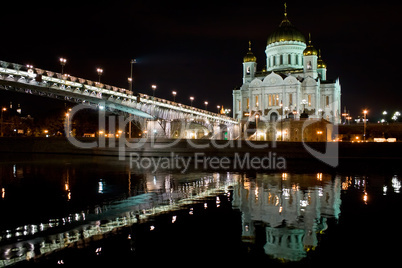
233;4;341;140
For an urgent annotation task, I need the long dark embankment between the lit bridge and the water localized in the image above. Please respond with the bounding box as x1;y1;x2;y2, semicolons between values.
0;137;402;170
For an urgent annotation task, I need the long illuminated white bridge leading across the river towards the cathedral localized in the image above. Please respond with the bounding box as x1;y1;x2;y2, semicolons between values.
0;61;240;139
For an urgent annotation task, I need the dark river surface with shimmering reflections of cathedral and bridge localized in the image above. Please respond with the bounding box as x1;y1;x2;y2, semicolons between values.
0;155;402;267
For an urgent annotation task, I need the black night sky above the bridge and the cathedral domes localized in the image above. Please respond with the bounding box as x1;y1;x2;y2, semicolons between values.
0;0;402;119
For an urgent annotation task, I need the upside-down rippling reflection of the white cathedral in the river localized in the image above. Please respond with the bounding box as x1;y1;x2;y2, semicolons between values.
233;173;341;261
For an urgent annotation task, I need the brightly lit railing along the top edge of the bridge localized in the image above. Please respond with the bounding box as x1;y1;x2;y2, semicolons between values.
0;61;238;124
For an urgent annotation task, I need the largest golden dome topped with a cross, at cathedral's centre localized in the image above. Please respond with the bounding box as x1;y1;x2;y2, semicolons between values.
267;7;306;45
